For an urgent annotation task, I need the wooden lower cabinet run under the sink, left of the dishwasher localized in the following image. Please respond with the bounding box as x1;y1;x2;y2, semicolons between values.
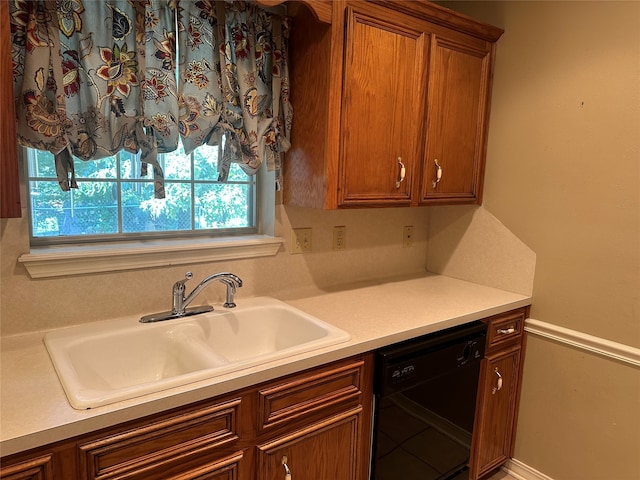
0;354;373;480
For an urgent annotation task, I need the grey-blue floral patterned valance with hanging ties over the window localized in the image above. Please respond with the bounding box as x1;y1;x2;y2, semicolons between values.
10;0;292;198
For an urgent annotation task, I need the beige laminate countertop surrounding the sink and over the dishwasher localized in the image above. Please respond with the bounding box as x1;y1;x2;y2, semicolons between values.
0;273;531;456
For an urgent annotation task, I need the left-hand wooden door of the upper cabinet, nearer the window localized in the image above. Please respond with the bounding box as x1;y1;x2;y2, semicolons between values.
338;5;427;206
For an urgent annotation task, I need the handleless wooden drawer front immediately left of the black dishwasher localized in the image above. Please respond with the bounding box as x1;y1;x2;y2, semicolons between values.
258;360;364;432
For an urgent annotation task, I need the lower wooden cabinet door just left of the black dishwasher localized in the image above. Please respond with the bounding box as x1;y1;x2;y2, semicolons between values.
257;408;368;480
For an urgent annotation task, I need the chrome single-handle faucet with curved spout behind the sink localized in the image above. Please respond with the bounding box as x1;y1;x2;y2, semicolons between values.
140;272;242;323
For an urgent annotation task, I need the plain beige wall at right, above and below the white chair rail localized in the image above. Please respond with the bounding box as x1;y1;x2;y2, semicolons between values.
440;1;640;480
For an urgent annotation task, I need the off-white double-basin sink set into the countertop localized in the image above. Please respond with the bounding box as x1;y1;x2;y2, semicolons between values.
44;297;350;409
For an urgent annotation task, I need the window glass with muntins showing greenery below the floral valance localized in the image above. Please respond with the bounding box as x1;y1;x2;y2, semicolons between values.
25;139;258;245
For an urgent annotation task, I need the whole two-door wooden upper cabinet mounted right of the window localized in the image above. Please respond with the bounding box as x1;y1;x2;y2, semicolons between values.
283;0;502;209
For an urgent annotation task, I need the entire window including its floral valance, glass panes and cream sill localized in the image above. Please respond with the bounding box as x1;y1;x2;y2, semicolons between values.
10;0;292;278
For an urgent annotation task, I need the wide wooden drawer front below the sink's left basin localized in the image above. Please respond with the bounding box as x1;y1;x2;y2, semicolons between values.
78;399;241;480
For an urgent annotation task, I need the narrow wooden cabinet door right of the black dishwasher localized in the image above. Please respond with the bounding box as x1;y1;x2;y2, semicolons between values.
469;345;521;480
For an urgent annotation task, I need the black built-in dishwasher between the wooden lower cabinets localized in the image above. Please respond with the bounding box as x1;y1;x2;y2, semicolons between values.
371;322;486;480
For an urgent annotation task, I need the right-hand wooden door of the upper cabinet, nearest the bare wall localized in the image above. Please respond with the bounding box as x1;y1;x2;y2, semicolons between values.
421;35;493;203
